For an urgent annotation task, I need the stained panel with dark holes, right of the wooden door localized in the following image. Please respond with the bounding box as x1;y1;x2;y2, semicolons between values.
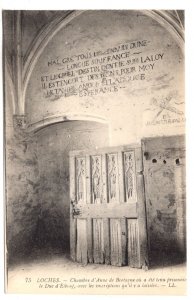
142;136;186;259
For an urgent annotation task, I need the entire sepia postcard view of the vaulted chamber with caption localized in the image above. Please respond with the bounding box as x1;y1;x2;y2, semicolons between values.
1;9;187;295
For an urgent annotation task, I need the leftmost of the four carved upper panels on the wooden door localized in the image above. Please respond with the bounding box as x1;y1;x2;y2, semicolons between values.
76;158;86;202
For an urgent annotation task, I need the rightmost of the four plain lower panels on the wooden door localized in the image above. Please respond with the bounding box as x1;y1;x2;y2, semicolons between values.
127;219;141;268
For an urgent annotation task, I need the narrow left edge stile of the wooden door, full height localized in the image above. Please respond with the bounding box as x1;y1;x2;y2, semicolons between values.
69;156;77;261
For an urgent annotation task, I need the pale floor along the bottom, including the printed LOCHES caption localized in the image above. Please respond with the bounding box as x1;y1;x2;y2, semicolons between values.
7;253;186;295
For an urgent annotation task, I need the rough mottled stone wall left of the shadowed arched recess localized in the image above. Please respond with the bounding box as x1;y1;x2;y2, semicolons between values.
5;78;40;262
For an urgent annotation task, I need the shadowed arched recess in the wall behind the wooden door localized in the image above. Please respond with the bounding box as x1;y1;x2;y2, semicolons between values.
34;120;109;253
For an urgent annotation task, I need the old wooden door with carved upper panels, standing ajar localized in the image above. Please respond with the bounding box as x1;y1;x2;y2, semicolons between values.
70;146;148;268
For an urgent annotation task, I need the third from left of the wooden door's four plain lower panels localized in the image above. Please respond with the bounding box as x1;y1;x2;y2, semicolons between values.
110;219;122;266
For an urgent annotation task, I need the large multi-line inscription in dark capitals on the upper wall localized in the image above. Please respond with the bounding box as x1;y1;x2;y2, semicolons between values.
40;40;164;100
